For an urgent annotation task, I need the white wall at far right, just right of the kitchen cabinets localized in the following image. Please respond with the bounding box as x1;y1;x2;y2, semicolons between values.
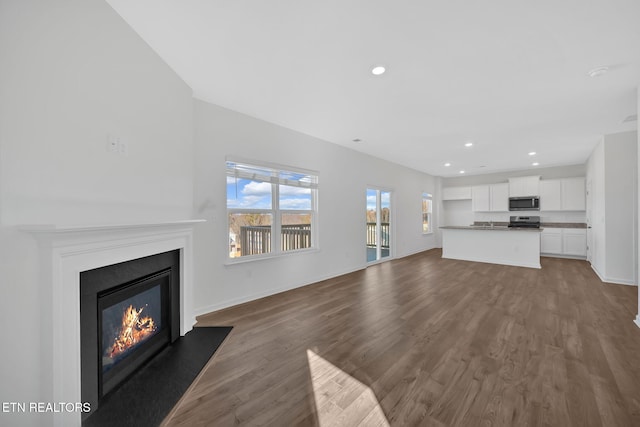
587;132;638;284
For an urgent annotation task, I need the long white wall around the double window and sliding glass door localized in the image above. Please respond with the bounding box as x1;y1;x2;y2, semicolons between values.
195;101;438;313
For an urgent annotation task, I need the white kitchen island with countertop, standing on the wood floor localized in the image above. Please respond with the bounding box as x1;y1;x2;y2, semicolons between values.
440;225;541;268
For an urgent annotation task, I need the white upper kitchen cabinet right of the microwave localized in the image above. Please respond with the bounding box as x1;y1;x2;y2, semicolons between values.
540;178;586;211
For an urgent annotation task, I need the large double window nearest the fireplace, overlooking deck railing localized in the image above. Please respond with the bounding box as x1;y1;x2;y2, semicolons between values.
227;161;318;258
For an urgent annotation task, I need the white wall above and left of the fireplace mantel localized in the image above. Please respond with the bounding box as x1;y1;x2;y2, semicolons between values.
0;0;194;425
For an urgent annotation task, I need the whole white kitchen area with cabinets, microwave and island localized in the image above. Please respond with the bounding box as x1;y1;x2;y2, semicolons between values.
440;175;588;268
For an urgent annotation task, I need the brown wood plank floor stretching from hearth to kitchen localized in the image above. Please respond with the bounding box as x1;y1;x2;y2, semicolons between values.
164;249;640;426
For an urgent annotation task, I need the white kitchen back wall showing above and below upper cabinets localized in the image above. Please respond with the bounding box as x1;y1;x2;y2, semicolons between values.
442;165;586;225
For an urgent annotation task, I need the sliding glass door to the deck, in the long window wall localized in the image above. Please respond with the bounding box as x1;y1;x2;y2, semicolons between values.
366;188;391;262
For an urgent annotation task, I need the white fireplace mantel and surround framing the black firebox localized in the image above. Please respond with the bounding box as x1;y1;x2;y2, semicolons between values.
19;220;205;426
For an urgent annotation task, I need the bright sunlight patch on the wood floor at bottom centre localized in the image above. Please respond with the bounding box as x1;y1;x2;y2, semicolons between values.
307;350;389;427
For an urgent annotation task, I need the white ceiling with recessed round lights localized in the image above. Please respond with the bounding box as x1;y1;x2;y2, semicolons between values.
107;0;640;177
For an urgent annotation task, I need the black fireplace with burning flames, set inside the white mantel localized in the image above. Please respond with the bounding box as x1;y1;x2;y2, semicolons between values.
80;250;180;415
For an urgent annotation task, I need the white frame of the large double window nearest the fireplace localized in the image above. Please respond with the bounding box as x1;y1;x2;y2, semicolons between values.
225;157;319;264
